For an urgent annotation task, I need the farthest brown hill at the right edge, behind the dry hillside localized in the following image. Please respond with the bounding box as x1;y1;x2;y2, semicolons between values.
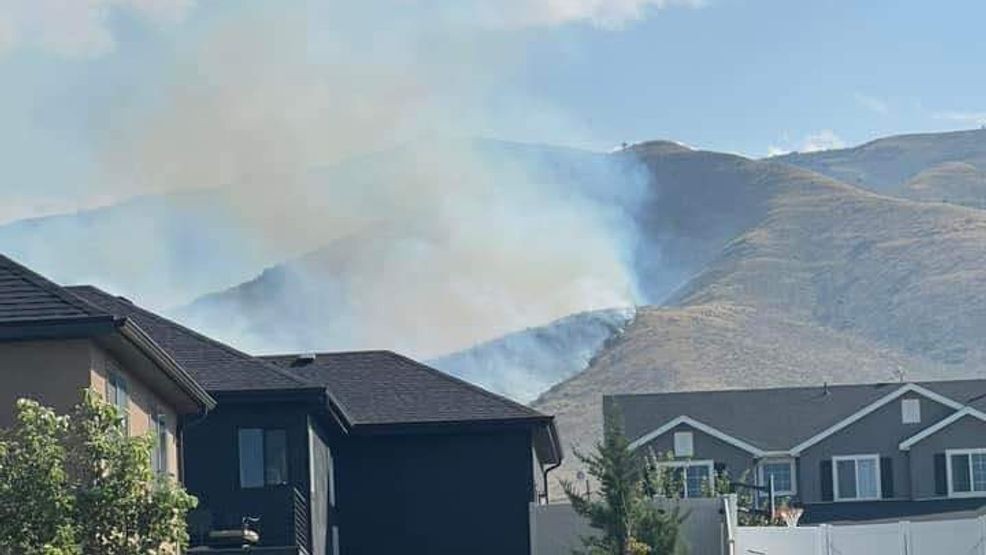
773;129;986;208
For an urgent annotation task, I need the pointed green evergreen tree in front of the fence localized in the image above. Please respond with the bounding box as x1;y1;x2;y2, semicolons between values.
562;422;684;555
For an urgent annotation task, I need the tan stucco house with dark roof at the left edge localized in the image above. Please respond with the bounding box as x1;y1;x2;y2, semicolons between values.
0;255;215;477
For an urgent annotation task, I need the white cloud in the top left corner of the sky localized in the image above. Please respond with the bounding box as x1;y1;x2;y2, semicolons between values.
0;0;195;58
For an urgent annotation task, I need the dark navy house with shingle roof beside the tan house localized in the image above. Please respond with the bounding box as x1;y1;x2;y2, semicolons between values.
67;286;561;555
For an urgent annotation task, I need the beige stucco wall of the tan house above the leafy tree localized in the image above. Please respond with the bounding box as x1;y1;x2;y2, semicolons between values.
0;339;178;480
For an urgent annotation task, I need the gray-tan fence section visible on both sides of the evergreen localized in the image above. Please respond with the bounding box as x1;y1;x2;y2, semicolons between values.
531;495;736;555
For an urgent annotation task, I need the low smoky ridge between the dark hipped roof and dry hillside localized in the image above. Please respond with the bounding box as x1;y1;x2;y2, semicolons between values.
428;308;634;403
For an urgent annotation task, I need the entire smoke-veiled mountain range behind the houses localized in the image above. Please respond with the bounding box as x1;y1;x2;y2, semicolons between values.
11;131;986;496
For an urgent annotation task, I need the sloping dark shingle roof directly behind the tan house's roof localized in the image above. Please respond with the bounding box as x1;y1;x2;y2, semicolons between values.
65;285;310;392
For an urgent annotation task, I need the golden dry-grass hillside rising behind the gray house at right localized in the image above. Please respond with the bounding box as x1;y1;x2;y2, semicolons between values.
534;150;986;494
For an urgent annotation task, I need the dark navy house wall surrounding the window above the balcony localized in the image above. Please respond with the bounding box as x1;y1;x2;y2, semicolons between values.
184;403;310;547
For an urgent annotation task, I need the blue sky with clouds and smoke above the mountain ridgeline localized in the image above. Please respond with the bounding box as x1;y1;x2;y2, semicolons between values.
0;0;986;221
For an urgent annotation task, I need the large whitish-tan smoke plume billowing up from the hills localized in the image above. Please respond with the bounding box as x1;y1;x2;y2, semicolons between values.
82;3;660;356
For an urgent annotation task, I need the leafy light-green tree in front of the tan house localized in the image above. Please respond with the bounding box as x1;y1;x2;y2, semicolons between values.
0;391;196;555
